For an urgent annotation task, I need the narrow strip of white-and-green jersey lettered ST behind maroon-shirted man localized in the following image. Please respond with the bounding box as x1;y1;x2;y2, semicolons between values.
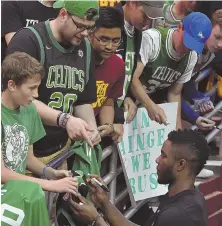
116;21;135;106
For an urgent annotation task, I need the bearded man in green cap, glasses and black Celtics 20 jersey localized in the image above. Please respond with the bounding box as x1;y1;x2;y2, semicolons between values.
7;0;101;163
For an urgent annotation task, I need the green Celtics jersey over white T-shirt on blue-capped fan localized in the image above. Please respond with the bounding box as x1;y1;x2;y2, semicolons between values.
140;28;197;94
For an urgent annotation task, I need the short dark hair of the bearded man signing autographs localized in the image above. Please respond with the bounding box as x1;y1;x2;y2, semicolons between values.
168;129;209;176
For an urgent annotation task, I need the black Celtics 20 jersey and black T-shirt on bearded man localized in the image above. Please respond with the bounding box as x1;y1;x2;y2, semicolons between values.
6;21;96;157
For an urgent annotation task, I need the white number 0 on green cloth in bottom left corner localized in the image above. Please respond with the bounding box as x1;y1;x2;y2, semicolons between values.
1;203;25;226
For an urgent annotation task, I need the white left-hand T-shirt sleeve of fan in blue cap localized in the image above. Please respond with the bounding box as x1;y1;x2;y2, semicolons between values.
140;29;161;66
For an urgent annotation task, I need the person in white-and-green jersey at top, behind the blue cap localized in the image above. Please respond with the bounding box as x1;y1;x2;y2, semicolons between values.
155;0;197;27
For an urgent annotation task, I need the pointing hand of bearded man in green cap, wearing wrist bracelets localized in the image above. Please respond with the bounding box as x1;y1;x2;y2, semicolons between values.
66;116;93;147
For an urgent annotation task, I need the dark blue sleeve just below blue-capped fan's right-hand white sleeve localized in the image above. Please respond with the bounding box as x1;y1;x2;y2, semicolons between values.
183;79;205;102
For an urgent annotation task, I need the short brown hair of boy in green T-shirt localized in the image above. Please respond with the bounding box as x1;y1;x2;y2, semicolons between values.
1;52;44;91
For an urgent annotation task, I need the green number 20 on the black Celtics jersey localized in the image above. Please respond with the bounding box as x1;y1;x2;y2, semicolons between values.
48;92;77;113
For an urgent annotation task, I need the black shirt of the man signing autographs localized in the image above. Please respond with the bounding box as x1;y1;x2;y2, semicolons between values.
143;189;208;226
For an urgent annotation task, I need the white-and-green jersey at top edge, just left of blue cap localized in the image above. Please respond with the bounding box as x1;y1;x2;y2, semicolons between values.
155;3;181;27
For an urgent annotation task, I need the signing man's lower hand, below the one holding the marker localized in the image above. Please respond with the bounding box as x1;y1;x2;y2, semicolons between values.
68;194;98;225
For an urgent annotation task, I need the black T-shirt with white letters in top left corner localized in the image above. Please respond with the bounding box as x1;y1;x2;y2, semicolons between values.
1;1;59;60
